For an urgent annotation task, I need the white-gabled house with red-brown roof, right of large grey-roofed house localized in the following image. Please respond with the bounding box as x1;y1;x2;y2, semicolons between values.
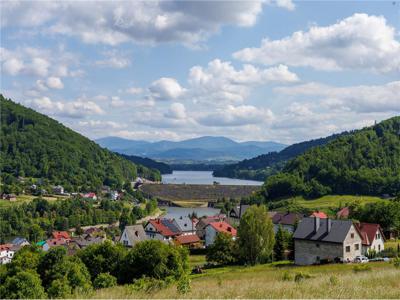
355;223;385;255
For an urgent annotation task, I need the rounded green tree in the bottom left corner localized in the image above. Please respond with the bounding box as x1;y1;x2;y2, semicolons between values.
0;271;46;299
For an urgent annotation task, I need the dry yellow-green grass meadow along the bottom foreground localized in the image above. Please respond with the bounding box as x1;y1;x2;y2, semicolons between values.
82;257;400;299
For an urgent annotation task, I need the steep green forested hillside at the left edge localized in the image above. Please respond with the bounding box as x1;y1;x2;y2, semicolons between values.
0;95;160;191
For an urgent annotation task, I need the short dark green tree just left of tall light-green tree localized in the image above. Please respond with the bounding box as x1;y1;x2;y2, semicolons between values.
206;233;236;265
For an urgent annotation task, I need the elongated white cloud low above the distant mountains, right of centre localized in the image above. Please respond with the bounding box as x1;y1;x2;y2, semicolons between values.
197;105;273;126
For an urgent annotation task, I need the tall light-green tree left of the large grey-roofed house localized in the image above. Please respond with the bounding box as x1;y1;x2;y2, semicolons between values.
238;205;275;265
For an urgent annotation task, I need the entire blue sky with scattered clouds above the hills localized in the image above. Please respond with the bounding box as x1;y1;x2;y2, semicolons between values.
0;0;400;144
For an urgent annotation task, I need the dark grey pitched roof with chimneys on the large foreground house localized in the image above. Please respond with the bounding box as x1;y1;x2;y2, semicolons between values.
293;217;353;243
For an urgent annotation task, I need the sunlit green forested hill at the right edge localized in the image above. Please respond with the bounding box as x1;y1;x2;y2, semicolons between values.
264;117;400;199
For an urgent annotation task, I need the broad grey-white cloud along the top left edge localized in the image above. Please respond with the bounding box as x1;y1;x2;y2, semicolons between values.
1;0;293;46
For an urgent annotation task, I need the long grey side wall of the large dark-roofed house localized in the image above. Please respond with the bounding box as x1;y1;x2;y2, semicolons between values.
294;239;343;265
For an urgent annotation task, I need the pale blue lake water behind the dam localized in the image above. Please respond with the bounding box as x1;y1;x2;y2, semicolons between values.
162;171;263;185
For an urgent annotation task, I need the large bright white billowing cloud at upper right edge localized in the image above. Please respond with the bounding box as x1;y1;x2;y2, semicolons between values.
233;14;400;72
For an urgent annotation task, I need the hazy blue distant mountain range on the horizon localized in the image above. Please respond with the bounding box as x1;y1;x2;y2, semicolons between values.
96;136;286;161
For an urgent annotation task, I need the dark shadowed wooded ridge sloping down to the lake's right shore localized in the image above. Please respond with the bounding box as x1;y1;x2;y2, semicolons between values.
213;132;348;181
